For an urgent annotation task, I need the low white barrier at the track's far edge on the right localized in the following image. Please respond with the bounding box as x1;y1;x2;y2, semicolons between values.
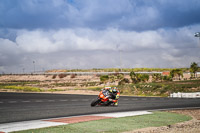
170;92;200;98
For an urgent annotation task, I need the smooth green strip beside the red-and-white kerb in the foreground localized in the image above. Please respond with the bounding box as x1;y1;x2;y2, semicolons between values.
11;112;192;133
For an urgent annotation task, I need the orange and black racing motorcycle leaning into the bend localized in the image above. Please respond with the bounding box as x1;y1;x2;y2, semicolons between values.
91;90;118;107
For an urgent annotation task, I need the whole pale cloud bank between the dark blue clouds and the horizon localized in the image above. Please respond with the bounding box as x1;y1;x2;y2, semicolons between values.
0;25;200;72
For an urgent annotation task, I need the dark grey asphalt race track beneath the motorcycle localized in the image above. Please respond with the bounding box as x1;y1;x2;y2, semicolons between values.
0;92;200;123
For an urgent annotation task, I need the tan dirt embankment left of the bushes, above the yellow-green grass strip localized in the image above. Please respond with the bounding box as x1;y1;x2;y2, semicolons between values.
0;74;102;91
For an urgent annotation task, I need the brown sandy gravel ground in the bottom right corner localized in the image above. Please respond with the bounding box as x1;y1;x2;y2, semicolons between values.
126;109;200;133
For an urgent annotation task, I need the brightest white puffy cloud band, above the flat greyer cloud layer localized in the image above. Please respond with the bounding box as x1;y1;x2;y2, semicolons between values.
13;29;170;53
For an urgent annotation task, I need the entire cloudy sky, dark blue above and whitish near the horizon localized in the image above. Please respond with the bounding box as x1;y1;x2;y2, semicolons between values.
0;0;200;73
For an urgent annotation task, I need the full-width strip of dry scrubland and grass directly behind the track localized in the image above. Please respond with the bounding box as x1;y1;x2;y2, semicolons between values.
0;74;200;96
